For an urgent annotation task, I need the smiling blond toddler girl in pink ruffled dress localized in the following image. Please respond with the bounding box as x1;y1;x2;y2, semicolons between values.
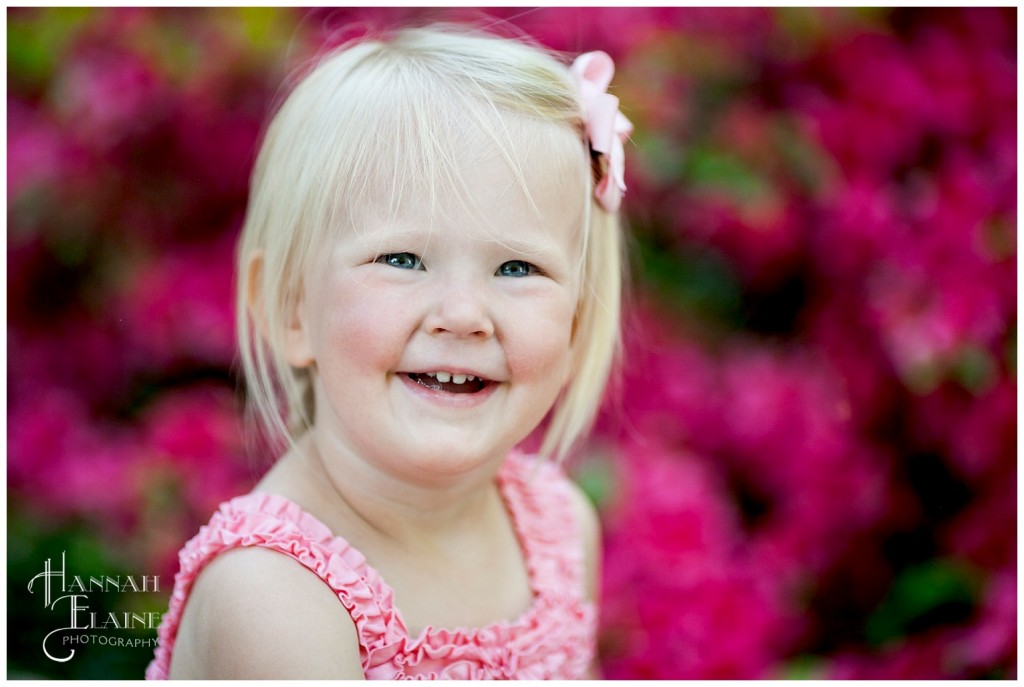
146;28;630;679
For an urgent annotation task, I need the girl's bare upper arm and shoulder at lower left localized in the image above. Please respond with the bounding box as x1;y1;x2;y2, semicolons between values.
170;548;364;680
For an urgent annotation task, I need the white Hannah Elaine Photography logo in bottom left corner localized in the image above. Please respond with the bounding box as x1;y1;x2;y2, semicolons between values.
29;552;161;663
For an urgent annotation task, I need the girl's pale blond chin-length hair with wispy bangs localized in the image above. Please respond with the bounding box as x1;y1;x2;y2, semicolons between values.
237;27;623;459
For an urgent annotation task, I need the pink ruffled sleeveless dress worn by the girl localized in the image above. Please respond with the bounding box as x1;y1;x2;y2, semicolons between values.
145;453;596;680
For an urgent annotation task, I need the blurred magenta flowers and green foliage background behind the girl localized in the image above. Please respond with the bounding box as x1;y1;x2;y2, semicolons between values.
7;7;1017;679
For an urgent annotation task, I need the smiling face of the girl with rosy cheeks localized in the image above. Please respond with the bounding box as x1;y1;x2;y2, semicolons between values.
288;145;582;480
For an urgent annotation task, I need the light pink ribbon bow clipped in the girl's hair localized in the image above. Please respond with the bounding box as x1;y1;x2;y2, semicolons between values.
570;50;633;212
